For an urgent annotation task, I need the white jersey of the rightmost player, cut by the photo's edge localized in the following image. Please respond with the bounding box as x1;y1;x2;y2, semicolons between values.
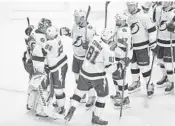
157;8;175;47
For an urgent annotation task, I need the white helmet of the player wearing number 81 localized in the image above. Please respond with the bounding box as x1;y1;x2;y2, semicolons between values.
101;28;115;44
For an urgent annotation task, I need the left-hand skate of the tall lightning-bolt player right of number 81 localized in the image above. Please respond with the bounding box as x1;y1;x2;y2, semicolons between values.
128;80;141;94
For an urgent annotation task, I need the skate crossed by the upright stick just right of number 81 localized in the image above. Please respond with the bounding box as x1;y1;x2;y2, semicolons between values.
114;97;130;109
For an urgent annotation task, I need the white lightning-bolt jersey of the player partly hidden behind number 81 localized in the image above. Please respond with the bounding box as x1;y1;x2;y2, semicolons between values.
72;24;94;60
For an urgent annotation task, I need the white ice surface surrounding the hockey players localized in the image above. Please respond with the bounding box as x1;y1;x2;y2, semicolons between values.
0;3;175;126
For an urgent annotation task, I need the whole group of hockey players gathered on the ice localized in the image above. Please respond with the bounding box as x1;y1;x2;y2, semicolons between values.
23;1;175;125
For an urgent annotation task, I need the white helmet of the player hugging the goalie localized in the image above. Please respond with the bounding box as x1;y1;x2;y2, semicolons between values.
46;26;59;40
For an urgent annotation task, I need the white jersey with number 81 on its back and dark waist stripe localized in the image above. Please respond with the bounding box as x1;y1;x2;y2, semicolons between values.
80;36;117;80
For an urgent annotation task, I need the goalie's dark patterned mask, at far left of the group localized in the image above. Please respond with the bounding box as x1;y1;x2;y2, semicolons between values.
38;18;52;33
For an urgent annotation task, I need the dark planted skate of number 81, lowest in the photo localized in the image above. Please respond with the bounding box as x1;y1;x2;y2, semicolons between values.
91;112;108;126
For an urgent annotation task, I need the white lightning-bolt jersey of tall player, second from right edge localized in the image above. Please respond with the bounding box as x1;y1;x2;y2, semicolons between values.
128;10;157;50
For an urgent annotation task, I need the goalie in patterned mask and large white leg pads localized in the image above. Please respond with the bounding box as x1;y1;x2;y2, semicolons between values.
27;18;61;119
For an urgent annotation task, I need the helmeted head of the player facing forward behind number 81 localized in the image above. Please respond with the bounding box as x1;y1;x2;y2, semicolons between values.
74;9;86;25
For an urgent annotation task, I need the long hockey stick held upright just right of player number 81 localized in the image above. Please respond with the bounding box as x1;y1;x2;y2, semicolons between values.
119;44;128;120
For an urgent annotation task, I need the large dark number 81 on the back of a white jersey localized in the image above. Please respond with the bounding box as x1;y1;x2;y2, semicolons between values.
86;46;99;64
